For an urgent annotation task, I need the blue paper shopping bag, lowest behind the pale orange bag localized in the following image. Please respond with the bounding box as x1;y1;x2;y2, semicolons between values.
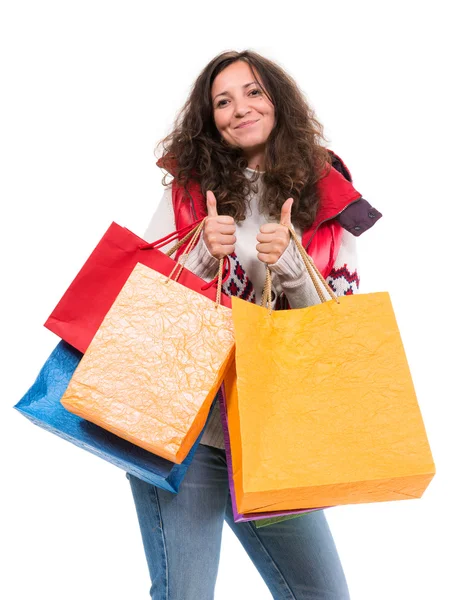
14;341;200;493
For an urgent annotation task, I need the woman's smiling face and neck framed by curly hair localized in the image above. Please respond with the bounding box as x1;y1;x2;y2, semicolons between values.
211;61;274;168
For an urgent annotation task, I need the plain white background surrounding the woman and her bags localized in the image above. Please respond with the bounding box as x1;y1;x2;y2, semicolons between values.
0;0;470;600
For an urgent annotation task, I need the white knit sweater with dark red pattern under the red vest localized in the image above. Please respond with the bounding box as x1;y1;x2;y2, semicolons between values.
144;169;359;449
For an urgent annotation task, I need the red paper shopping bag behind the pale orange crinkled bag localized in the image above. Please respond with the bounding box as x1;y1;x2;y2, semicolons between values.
45;222;231;352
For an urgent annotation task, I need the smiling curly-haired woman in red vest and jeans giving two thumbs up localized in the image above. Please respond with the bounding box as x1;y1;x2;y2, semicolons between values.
128;51;380;600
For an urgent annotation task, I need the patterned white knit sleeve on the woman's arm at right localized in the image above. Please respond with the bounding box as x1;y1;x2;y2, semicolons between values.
271;230;359;308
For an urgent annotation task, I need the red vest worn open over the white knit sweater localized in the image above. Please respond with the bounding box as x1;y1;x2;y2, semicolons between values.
157;155;361;277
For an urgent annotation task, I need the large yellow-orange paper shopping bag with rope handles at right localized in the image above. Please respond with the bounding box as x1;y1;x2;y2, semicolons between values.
225;230;435;513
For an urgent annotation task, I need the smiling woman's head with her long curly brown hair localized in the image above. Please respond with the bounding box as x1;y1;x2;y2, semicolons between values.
159;51;332;228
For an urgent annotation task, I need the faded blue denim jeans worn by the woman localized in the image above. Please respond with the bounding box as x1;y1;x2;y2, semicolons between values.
127;444;349;600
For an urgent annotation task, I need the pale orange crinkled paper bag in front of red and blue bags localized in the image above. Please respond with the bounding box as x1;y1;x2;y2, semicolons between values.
62;248;234;464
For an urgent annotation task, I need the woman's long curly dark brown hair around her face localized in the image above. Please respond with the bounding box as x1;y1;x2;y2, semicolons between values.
157;50;331;229
